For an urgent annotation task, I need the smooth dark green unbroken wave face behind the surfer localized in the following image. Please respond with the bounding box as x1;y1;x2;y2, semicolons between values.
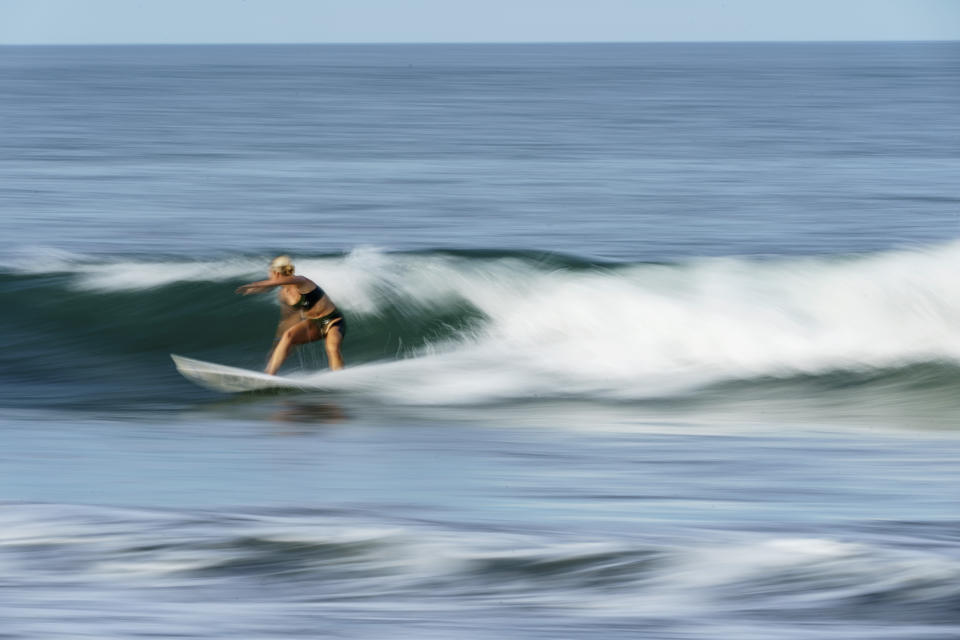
0;252;492;405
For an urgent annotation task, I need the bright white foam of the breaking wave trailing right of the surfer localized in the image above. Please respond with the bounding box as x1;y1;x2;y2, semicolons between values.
288;244;960;403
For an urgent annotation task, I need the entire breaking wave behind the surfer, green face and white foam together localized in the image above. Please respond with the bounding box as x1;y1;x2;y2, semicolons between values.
0;245;960;420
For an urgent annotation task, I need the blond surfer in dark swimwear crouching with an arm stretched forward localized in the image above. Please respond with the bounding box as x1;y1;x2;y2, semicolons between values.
237;256;347;375
